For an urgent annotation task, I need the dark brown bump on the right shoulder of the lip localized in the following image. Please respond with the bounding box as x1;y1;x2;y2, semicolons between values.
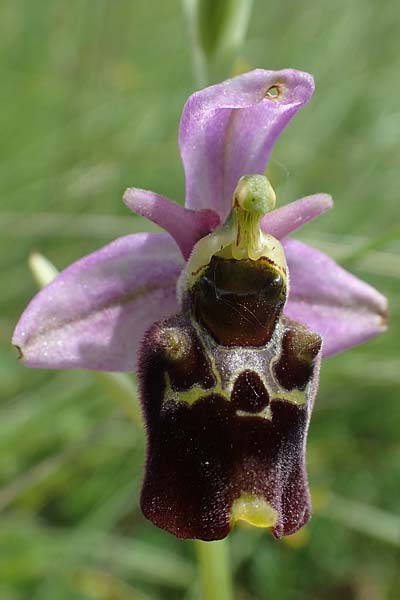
274;324;322;391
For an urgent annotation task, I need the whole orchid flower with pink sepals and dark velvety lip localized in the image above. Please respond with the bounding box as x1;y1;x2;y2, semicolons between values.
13;69;386;540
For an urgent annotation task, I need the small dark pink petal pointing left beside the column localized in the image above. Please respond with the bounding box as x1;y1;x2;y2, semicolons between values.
124;188;220;259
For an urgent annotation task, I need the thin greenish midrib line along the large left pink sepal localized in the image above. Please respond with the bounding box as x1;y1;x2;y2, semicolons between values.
15;277;176;359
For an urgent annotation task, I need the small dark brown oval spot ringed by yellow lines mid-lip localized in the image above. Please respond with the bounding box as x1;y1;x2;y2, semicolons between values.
231;369;269;413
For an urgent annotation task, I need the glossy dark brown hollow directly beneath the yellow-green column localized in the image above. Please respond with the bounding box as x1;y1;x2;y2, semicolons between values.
190;256;286;346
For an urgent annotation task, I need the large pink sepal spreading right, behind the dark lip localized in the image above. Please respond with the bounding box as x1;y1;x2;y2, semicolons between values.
283;240;387;357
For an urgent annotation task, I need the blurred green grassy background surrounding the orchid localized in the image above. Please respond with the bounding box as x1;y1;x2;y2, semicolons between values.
0;0;400;600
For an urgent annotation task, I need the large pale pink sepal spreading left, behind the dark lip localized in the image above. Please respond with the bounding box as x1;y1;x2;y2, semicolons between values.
13;233;184;371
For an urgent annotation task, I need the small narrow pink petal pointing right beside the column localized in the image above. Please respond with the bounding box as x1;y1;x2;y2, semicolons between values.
261;194;333;240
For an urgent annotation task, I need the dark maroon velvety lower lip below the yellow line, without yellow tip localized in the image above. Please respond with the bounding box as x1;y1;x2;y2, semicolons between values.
141;394;310;540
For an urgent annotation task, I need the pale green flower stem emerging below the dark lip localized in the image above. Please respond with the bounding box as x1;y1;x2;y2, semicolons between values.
194;540;233;600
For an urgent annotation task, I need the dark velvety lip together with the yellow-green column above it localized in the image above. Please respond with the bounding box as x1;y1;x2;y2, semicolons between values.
139;175;322;540
